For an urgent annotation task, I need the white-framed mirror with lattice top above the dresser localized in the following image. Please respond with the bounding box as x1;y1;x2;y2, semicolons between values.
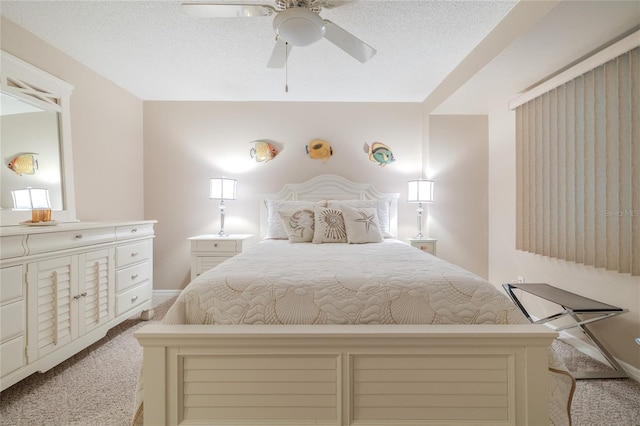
0;52;76;226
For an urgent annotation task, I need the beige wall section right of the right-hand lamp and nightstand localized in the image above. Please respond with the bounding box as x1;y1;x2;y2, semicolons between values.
429;115;489;279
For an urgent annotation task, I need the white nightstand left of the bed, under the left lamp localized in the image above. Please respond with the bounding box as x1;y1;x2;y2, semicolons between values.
189;234;253;280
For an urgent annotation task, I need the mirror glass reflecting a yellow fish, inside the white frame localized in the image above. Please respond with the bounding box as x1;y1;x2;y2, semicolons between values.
0;93;64;210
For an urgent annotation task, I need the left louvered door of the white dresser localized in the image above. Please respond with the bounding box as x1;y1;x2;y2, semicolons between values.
27;256;78;362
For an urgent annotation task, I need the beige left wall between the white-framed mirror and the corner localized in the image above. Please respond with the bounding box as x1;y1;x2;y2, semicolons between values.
0;18;144;221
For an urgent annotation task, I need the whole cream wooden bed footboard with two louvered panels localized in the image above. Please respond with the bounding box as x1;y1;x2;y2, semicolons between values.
135;324;557;426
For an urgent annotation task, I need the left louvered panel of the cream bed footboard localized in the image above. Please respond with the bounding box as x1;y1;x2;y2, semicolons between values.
179;354;340;425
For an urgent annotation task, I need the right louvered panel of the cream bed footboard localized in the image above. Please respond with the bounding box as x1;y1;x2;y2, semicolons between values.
353;355;513;423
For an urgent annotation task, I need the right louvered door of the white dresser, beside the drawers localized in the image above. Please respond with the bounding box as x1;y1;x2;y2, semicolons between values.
75;248;115;336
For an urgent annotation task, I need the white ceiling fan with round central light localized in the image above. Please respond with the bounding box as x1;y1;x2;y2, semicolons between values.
182;0;376;68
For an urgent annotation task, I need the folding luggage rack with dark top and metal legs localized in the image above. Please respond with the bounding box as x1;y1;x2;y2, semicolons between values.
502;283;629;380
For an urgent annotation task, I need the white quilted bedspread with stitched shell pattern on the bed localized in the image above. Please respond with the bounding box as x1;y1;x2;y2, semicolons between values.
136;239;574;425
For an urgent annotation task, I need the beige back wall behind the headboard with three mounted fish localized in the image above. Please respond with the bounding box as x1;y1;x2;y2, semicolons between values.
144;102;430;289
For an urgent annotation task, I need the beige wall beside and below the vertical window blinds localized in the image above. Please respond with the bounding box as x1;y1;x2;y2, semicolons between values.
489;111;640;368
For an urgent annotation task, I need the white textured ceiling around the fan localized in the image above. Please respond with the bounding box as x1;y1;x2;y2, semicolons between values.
0;0;517;102
